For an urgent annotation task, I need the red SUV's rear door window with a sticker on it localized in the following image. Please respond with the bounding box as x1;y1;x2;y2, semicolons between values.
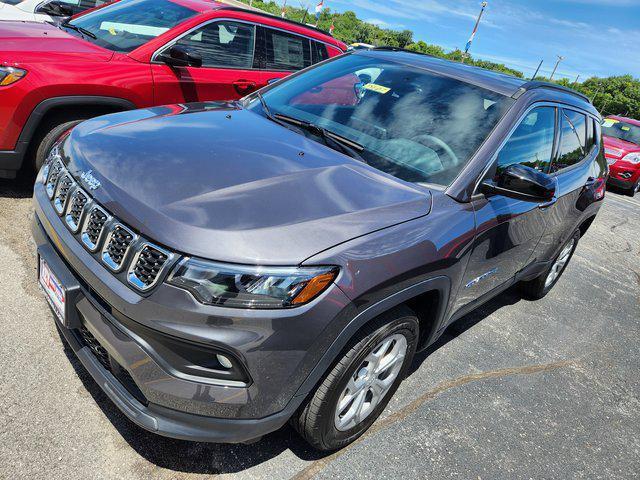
265;28;311;70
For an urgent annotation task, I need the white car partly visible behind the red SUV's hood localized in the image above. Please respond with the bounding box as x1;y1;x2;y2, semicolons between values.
0;0;107;22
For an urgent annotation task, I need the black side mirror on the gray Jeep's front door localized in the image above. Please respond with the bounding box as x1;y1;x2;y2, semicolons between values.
480;164;557;202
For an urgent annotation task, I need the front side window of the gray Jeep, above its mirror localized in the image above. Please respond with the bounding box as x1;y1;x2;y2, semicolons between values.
496;107;556;174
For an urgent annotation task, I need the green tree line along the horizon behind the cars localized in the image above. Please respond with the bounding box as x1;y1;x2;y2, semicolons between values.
241;0;640;119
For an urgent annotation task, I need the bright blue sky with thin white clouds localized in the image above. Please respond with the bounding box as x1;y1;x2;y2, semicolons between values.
324;0;640;81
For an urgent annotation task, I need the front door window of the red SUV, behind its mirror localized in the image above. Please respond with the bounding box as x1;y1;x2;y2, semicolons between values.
177;21;256;68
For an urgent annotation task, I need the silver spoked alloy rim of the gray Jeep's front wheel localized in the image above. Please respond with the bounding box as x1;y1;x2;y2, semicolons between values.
335;333;407;431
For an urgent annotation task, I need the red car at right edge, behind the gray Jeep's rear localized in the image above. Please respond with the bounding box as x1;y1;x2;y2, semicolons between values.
602;116;640;197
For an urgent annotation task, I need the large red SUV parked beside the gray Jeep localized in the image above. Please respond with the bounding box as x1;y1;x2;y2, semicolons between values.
0;0;346;178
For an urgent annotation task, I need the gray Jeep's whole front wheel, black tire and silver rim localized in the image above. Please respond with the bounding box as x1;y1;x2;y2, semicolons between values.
291;307;419;451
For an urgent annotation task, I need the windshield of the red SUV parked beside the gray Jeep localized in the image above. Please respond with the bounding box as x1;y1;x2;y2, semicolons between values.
66;0;197;52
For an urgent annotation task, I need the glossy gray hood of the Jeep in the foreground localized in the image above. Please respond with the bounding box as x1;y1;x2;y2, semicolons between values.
63;103;431;265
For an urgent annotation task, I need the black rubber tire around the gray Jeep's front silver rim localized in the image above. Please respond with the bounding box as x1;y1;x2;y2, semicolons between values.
320;316;418;448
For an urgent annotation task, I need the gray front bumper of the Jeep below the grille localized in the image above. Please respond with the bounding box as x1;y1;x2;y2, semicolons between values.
33;180;350;443
